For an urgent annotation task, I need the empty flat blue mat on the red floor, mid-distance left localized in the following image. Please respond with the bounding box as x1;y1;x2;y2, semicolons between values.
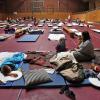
17;34;40;42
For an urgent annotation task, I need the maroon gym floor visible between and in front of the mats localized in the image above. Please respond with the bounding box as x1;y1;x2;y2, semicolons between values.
0;25;100;100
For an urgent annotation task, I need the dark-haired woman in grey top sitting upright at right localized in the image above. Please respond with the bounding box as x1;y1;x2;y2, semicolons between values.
73;31;95;61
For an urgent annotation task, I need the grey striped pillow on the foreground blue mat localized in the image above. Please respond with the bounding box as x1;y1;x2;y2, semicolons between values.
23;69;52;86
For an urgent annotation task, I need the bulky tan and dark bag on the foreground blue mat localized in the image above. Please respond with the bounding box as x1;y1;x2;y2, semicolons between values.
60;63;85;83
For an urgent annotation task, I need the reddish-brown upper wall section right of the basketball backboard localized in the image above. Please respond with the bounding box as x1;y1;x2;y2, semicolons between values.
44;0;88;12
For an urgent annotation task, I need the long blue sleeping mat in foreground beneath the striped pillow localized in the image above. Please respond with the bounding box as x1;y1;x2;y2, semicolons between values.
0;63;90;88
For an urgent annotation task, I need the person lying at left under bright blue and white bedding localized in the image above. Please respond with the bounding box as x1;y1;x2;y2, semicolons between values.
0;52;27;83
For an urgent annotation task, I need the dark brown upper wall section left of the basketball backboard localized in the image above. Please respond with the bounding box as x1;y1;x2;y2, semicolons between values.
6;0;32;13
